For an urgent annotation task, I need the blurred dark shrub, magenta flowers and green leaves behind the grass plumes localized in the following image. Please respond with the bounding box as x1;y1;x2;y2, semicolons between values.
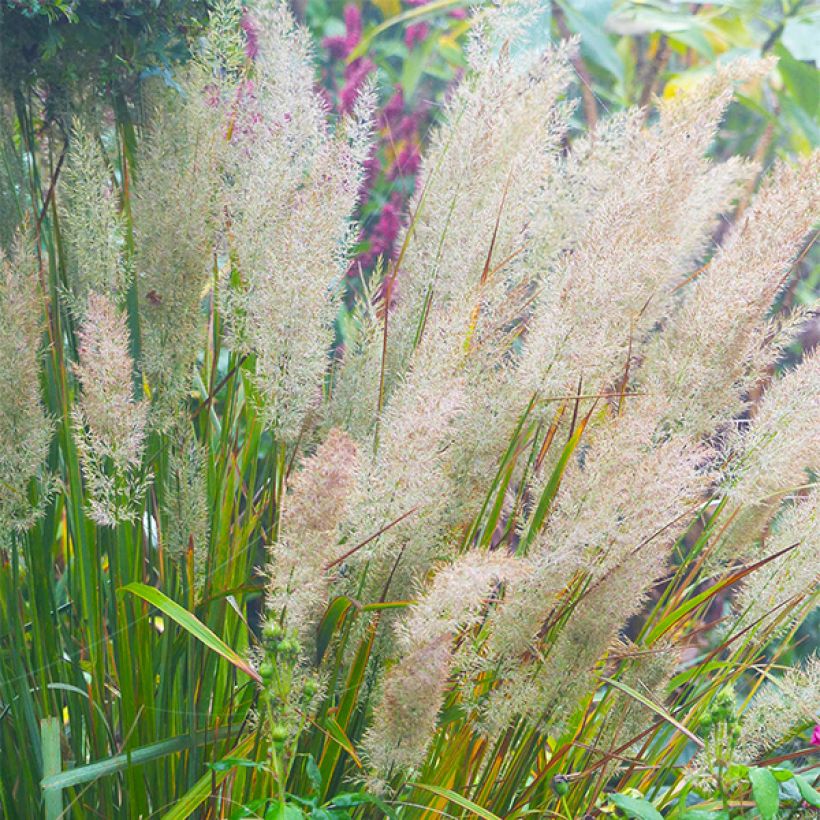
0;0;820;288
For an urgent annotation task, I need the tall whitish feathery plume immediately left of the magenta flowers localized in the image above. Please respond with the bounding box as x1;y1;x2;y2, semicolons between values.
223;3;373;442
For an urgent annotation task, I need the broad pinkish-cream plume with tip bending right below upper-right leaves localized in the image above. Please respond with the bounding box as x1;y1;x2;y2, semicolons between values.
517;63;768;404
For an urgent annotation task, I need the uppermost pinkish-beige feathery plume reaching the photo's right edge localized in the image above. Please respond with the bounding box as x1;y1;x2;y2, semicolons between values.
641;150;820;435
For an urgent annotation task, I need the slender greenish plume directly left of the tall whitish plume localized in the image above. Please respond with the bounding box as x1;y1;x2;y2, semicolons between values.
132;65;224;430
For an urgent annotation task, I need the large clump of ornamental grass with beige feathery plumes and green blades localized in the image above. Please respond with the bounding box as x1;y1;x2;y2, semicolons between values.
0;3;820;818
